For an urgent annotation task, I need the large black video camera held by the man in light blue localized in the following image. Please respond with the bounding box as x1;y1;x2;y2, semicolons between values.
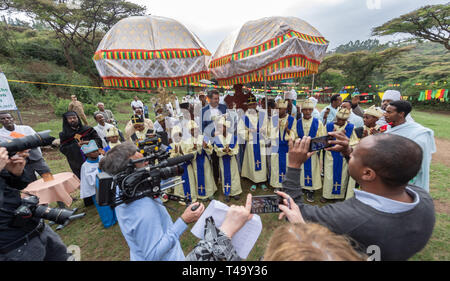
96;154;194;207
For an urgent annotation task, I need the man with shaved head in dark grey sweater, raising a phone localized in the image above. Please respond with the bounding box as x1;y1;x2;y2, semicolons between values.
278;132;435;260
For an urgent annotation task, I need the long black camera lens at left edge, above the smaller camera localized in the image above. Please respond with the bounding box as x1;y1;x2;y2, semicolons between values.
0;130;55;157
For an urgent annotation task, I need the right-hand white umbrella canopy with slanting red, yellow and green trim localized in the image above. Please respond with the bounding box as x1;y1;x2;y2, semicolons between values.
209;17;328;86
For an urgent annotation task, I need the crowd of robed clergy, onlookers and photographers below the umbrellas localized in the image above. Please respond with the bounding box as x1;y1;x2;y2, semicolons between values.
0;86;435;260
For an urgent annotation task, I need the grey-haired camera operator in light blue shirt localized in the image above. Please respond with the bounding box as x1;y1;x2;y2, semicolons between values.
99;142;205;261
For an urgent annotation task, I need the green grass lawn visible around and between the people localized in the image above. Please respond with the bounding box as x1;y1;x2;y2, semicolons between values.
20;97;450;261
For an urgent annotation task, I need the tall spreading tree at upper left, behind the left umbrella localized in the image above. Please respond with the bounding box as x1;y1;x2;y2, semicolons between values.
11;0;146;85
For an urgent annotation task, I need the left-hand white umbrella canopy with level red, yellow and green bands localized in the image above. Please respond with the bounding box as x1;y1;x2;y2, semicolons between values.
93;16;211;88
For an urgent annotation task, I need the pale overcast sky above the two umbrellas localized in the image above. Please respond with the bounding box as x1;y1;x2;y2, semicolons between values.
128;0;448;53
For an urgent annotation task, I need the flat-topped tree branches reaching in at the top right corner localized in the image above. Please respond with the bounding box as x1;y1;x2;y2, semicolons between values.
372;2;450;50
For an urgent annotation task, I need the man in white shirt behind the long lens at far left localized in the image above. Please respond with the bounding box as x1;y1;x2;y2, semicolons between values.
0;112;50;180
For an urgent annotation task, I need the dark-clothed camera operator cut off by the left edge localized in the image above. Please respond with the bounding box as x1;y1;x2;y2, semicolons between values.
0;147;70;261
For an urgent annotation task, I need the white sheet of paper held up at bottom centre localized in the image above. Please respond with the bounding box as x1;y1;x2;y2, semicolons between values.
191;200;262;259
